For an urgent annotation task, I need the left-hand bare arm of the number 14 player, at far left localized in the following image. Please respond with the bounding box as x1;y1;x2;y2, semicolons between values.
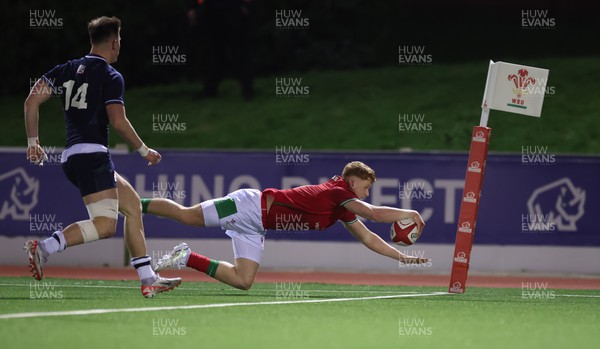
23;79;52;165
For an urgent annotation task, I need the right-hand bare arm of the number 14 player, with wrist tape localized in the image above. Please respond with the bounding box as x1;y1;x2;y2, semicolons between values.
106;104;162;166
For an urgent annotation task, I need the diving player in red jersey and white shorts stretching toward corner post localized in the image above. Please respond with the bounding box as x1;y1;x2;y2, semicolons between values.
142;161;429;290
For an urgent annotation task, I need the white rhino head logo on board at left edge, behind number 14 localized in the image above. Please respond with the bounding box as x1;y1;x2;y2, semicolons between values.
0;167;40;221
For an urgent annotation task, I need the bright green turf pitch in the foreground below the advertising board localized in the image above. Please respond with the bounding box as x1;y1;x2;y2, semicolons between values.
0;277;600;349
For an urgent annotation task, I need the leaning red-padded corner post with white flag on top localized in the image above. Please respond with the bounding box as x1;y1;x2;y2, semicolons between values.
448;61;548;293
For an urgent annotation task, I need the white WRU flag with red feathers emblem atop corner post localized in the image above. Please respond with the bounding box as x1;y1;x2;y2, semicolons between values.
482;61;548;117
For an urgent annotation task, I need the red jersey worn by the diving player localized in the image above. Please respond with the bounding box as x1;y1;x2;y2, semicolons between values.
263;176;358;230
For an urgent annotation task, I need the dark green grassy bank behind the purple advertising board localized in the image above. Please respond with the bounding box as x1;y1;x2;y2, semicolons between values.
0;57;600;154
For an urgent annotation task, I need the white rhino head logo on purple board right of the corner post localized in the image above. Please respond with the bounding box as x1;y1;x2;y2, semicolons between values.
527;177;585;231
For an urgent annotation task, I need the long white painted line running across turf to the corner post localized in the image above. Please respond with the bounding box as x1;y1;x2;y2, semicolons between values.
0;292;451;319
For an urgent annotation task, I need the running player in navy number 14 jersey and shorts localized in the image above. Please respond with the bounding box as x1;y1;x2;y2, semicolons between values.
25;17;181;298
